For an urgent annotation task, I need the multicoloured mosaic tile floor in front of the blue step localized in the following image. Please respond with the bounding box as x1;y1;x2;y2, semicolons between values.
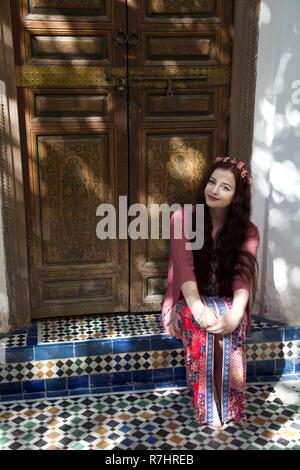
0;381;300;450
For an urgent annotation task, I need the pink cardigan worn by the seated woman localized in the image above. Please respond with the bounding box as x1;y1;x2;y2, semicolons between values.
162;208;259;334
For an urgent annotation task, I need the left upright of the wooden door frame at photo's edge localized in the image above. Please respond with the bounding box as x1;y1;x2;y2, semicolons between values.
0;0;31;330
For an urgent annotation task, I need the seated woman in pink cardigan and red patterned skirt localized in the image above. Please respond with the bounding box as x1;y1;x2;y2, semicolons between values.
162;157;259;428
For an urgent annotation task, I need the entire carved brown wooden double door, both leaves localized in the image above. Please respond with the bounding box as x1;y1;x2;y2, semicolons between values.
11;0;234;317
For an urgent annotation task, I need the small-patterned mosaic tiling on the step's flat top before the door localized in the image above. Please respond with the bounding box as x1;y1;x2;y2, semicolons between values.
38;312;278;344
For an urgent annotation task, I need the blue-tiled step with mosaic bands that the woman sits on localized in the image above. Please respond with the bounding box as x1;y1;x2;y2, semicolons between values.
0;313;300;401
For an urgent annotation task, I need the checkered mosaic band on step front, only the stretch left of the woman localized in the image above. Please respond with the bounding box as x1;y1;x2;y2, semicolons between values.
0;349;184;384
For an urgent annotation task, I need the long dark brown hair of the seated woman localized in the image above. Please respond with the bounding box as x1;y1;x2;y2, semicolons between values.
193;162;258;302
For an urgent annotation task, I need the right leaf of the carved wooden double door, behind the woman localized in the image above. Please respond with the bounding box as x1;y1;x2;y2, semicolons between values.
128;0;233;311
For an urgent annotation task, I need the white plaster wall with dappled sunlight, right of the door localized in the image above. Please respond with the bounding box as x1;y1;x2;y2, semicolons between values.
252;0;300;324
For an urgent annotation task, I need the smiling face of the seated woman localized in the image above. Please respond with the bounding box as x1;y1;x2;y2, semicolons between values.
204;168;235;209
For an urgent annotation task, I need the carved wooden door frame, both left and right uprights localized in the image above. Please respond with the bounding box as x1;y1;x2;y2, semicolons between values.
0;0;260;330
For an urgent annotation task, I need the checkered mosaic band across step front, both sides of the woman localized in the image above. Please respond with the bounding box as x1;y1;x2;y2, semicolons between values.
0;340;300;384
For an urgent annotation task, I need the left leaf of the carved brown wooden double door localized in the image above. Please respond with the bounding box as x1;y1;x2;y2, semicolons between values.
12;0;129;317
